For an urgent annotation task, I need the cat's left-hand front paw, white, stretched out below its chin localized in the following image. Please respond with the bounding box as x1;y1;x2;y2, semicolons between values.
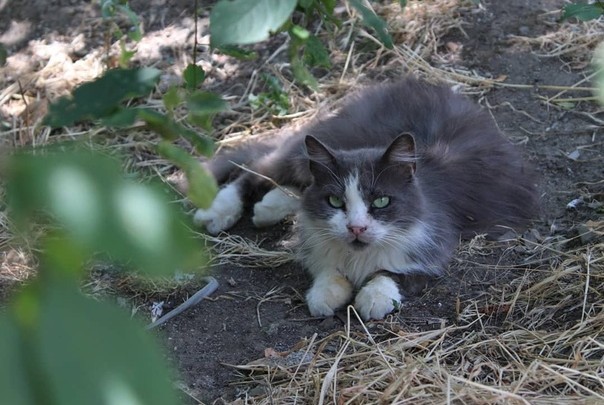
306;274;353;316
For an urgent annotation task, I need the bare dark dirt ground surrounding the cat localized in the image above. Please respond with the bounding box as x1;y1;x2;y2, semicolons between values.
0;0;604;403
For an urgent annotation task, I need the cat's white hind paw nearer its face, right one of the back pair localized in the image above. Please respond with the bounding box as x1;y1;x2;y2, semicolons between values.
252;188;300;228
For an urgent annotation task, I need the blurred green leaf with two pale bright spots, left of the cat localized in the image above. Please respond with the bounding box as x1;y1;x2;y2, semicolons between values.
7;148;203;275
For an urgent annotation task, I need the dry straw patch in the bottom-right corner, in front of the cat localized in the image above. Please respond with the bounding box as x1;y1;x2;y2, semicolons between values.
230;234;604;404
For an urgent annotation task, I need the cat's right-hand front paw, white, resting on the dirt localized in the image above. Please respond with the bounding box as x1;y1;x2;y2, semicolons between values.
354;276;402;321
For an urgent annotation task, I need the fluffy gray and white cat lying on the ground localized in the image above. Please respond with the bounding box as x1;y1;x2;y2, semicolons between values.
190;79;538;319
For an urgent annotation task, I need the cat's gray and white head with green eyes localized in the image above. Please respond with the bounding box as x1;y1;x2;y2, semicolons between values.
302;134;422;249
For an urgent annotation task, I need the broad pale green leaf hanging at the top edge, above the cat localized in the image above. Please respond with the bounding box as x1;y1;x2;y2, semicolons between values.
210;0;296;48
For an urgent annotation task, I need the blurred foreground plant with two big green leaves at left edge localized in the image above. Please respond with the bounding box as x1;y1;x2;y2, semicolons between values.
0;143;204;405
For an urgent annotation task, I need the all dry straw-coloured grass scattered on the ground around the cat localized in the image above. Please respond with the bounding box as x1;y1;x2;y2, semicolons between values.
0;0;604;404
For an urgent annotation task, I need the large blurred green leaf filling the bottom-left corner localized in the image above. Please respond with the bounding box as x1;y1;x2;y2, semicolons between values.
0;276;179;405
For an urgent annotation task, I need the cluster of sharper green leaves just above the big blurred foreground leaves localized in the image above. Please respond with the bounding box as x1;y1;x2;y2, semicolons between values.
44;68;226;207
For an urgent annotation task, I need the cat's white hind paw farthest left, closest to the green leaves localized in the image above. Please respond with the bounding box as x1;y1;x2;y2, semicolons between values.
193;184;243;235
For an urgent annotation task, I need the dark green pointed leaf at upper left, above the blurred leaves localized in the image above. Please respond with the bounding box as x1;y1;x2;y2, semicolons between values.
44;68;160;128
